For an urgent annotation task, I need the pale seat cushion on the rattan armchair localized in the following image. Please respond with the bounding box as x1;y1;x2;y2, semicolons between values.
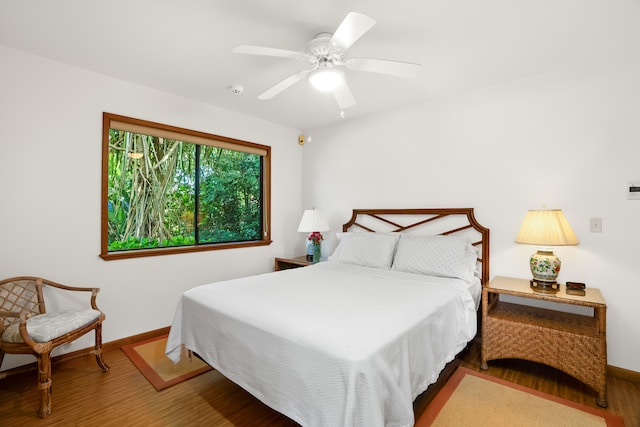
2;308;101;343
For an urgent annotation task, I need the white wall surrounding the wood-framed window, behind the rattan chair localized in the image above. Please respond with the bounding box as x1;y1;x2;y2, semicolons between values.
0;46;302;370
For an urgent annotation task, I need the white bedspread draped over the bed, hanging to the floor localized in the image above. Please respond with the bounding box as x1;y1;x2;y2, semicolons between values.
166;262;479;427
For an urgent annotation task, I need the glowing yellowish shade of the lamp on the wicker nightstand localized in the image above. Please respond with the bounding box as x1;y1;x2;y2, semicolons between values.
516;209;579;246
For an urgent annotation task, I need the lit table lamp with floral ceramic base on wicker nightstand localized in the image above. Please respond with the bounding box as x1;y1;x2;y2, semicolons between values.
516;209;579;293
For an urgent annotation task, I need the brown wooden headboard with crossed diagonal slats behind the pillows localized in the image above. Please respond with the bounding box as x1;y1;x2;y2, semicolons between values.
342;208;489;286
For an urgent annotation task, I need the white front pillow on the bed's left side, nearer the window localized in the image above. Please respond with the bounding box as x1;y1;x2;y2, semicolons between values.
328;232;400;270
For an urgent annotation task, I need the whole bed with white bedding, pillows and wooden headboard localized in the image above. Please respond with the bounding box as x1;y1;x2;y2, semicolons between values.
166;208;489;427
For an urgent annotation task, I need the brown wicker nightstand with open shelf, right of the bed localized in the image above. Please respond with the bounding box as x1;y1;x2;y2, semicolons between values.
480;277;607;407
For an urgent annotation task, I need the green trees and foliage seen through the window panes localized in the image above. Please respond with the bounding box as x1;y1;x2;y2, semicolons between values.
107;129;264;252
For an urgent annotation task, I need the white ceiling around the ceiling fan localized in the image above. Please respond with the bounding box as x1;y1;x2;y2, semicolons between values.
0;0;640;130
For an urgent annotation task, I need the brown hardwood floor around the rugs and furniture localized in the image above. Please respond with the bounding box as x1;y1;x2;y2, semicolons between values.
0;342;640;427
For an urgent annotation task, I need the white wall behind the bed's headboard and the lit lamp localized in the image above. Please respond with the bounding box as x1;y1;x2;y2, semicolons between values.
302;58;640;372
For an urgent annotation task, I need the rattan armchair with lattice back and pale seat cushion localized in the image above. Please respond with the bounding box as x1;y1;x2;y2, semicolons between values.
0;276;109;418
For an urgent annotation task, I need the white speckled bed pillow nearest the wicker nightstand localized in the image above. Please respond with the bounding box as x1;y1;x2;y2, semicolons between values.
392;234;478;282
